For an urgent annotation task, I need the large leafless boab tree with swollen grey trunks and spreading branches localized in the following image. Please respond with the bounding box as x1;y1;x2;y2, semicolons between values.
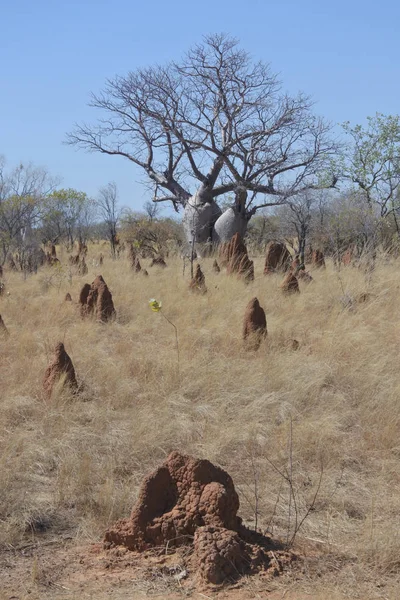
68;35;336;253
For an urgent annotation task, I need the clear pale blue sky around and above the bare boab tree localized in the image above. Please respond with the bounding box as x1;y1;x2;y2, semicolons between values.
0;0;400;209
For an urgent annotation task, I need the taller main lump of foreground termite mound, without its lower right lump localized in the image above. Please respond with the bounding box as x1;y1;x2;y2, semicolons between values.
105;452;239;551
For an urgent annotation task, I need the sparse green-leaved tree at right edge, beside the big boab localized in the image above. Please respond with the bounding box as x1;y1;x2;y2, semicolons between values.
343;113;400;236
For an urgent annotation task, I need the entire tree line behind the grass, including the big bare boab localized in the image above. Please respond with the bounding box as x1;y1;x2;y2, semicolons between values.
0;35;400;263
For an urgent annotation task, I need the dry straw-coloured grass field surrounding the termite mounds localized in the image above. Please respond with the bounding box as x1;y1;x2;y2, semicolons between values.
0;247;400;598
